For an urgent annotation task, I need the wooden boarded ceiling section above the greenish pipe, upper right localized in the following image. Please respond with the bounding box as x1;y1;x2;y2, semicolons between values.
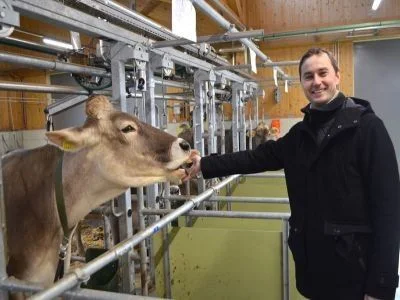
246;0;400;34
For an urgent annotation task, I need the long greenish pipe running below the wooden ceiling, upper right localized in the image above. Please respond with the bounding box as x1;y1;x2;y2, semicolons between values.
262;20;400;41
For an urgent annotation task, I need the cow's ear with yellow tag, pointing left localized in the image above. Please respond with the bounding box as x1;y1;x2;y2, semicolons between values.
46;128;97;152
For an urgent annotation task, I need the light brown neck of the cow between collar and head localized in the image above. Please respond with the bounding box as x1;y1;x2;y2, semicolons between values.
59;149;126;228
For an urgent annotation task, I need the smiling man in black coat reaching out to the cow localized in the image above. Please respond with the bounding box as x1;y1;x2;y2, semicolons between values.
188;48;400;300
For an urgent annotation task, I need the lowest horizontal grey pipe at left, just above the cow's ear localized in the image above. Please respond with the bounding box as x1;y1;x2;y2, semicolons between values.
0;81;89;95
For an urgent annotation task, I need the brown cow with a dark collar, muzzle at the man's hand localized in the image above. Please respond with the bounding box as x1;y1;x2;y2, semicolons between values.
3;95;191;286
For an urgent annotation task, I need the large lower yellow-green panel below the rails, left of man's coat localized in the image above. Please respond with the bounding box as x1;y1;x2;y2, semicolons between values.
155;228;282;300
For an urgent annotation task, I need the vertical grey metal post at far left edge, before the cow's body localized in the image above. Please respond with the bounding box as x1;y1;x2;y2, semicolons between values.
0;156;8;300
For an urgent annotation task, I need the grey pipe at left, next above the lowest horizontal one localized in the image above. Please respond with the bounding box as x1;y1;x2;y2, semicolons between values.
0;52;111;77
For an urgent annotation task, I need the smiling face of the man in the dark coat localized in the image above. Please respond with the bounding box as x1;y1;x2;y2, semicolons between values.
300;53;340;106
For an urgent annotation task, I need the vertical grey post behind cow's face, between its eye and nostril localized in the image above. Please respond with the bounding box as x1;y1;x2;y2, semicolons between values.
146;61;160;288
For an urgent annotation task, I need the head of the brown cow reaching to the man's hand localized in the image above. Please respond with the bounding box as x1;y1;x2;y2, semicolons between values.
46;95;191;187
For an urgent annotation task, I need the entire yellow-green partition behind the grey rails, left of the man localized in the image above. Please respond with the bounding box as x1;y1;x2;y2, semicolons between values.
154;178;305;300
